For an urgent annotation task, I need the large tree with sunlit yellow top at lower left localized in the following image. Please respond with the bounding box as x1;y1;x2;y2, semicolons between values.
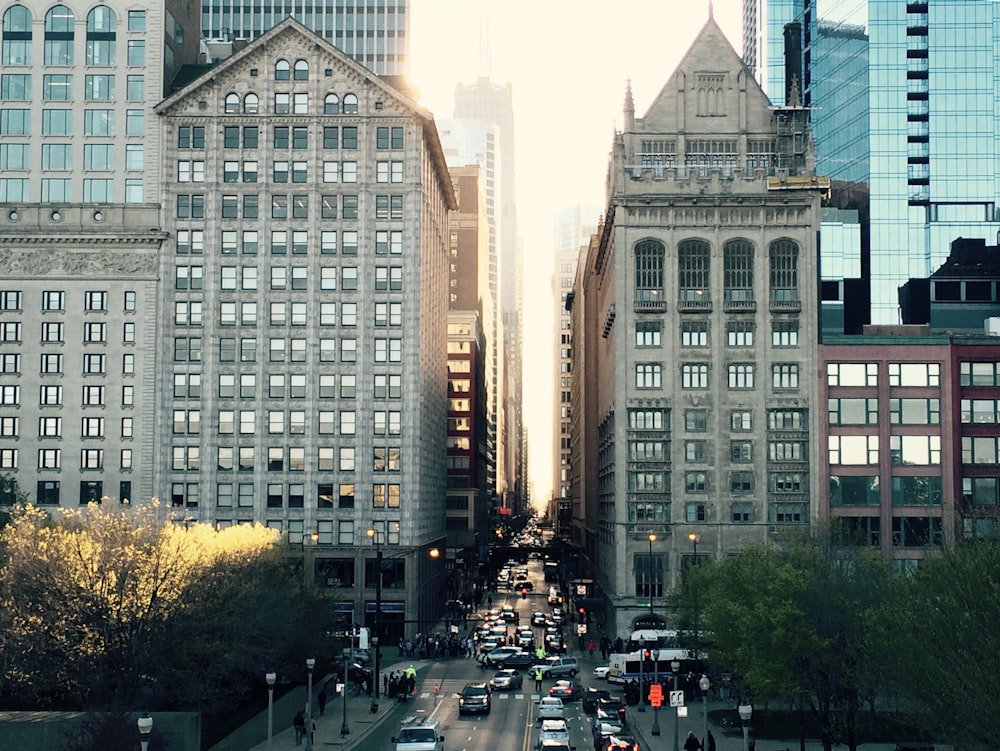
0;504;332;712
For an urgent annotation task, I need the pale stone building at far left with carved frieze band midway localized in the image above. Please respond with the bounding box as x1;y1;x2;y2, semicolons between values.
0;0;198;508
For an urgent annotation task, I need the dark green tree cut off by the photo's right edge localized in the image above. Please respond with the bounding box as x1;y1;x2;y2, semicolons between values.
894;540;1000;749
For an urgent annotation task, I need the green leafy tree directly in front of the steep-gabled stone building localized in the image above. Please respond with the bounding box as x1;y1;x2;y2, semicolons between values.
676;541;893;751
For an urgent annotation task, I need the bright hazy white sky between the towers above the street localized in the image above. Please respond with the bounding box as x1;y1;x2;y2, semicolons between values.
410;0;743;505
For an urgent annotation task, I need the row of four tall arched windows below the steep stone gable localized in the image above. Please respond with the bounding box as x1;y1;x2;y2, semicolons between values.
635;239;799;304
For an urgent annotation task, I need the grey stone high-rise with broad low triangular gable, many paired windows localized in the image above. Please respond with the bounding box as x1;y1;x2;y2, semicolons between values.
156;19;455;642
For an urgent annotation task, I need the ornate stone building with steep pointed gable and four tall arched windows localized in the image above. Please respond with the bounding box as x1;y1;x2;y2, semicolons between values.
573;13;821;633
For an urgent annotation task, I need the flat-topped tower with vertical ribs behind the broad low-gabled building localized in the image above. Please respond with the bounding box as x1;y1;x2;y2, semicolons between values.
201;0;410;76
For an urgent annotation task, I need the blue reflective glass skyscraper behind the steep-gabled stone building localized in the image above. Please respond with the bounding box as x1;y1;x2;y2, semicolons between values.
744;0;1000;323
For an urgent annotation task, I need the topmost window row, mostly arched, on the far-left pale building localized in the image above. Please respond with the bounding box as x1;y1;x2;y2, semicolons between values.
0;5;146;66
